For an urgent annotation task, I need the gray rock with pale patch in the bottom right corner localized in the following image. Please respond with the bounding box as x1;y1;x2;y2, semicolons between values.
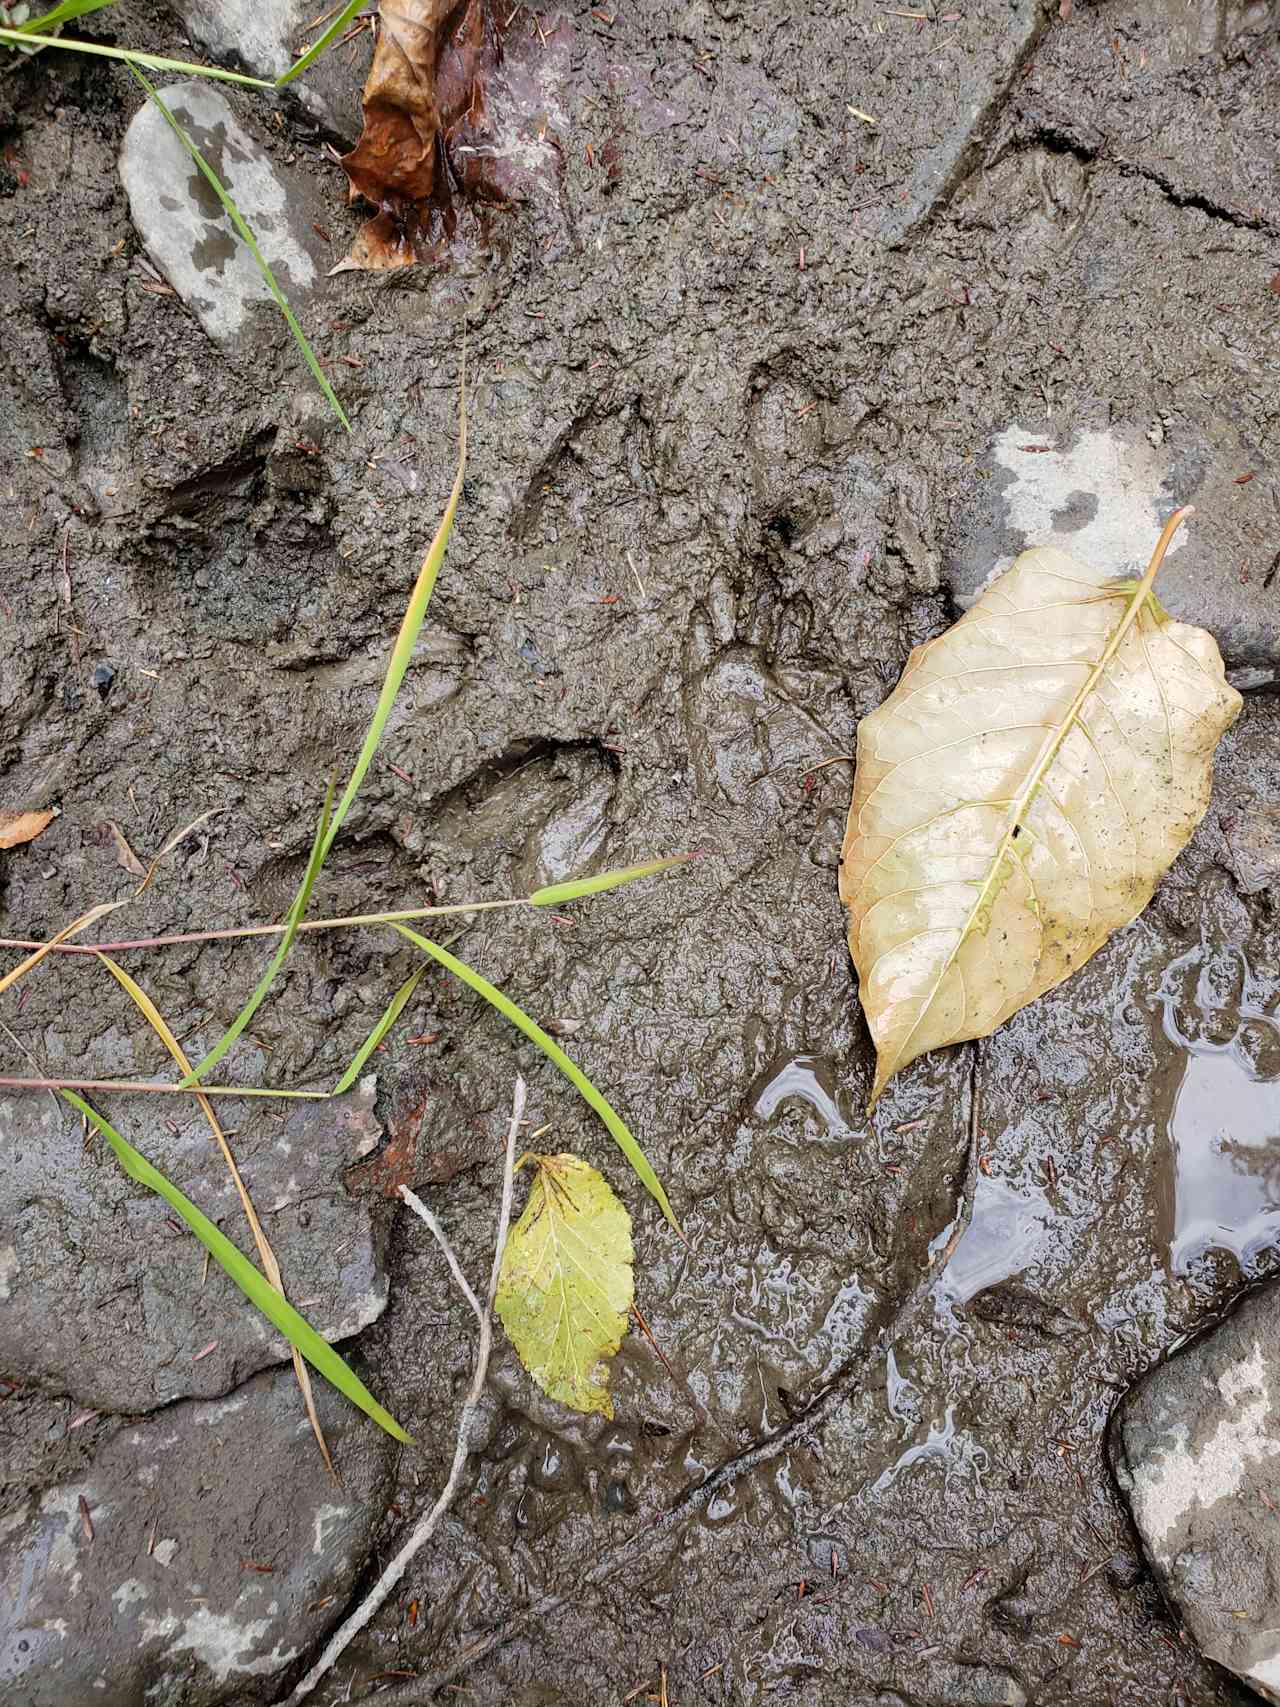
1109;1285;1280;1702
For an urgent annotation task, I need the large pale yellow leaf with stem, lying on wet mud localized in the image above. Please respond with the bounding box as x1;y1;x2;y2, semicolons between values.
840;521;1241;1103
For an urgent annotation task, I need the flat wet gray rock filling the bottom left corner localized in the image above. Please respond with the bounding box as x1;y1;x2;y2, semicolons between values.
0;1371;394;1707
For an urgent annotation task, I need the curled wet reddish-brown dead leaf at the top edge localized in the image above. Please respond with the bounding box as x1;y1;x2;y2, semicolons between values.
335;0;498;271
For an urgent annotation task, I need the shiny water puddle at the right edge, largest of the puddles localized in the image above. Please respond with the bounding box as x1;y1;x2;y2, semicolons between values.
1159;961;1280;1273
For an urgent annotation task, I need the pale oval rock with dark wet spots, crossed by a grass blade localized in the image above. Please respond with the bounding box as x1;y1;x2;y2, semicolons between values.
119;79;333;343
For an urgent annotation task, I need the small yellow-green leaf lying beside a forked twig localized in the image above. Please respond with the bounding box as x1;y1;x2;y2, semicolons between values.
495;1156;635;1417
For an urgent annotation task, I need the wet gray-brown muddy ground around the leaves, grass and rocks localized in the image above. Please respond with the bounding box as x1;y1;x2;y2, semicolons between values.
0;0;1280;1707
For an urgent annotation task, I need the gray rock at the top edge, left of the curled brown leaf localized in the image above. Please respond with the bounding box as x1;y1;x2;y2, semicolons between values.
171;0;372;142
